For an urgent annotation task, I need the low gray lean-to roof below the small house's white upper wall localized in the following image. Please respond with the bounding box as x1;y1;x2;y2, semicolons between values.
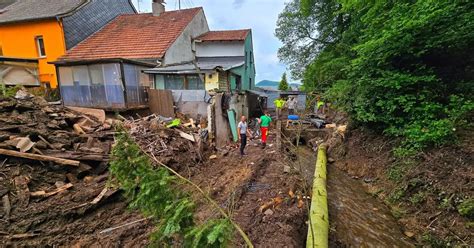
145;56;245;74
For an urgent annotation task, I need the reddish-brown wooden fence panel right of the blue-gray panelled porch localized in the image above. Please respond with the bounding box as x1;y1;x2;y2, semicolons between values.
148;89;174;117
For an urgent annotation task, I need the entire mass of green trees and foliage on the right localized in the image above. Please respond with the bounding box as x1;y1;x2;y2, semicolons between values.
276;0;474;151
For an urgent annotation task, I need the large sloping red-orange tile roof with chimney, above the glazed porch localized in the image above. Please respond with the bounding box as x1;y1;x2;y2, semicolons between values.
59;8;202;60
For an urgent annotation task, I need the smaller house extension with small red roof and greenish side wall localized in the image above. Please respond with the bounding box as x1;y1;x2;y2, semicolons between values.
145;29;255;116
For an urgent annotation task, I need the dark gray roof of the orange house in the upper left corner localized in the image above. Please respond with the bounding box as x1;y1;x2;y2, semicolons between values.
0;0;88;24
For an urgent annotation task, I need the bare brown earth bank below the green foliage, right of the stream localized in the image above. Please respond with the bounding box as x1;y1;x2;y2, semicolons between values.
330;129;474;247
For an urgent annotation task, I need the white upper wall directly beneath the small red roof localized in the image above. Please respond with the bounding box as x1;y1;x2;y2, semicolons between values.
196;41;245;57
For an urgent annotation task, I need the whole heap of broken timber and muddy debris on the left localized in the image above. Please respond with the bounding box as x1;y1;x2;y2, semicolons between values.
0;91;209;246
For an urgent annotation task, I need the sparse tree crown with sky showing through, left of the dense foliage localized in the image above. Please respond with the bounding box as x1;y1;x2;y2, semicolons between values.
275;0;347;79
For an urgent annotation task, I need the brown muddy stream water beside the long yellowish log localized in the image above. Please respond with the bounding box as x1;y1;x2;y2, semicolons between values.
297;148;413;247
